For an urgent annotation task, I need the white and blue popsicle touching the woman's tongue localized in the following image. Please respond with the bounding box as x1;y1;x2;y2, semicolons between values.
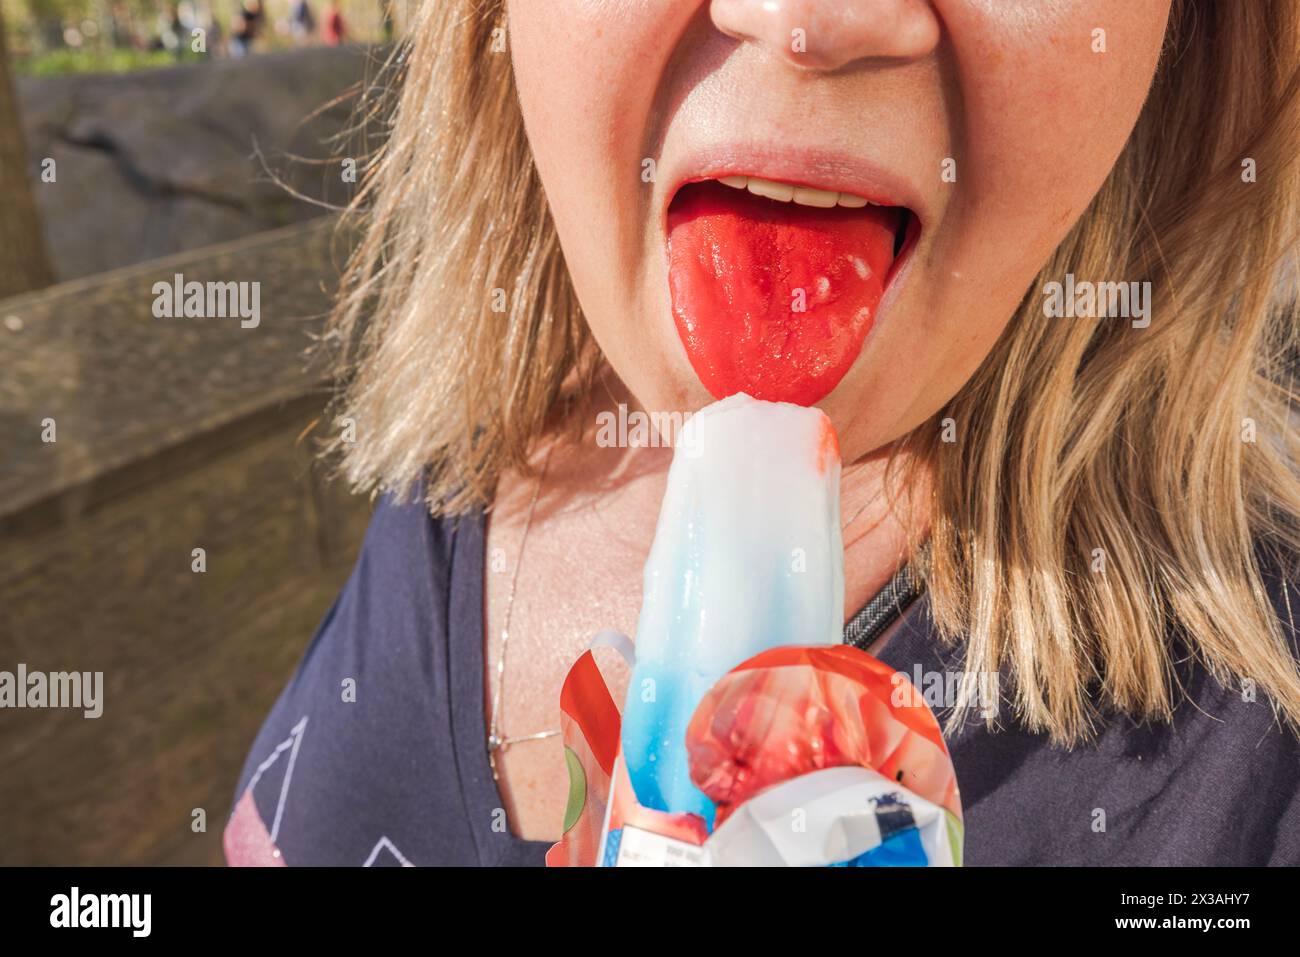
621;393;844;828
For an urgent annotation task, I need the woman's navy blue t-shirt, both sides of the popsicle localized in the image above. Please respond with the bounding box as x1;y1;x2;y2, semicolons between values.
225;501;1300;866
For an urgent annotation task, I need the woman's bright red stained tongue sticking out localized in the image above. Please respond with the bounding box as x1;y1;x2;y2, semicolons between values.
668;181;901;406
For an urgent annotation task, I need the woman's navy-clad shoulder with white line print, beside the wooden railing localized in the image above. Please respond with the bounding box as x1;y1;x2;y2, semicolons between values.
225;499;482;865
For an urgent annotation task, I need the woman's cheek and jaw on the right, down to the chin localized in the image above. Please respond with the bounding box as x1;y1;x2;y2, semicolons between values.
841;0;1167;449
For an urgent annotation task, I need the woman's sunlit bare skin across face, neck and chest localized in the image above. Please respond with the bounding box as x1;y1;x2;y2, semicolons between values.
486;0;1169;839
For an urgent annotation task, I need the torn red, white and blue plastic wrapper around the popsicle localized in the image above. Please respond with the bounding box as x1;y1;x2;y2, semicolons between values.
546;645;963;867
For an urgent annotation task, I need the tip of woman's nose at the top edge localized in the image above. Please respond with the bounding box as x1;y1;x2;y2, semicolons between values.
709;0;939;72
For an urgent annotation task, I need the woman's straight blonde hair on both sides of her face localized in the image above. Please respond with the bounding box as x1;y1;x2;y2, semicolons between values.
319;0;1300;745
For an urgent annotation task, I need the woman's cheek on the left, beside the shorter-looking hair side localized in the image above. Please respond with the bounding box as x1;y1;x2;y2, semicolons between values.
508;0;698;403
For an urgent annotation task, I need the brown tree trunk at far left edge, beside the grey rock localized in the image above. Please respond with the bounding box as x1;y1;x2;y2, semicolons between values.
0;9;53;298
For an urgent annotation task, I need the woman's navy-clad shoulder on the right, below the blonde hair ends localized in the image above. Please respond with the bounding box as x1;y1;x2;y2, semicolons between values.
949;538;1300;866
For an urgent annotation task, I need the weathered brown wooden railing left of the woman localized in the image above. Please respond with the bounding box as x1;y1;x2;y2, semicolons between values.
0;220;369;865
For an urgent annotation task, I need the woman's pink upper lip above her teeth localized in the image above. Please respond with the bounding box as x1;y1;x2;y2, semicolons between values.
659;143;927;226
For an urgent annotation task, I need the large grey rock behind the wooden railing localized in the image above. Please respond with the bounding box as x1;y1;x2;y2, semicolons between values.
18;47;384;281
